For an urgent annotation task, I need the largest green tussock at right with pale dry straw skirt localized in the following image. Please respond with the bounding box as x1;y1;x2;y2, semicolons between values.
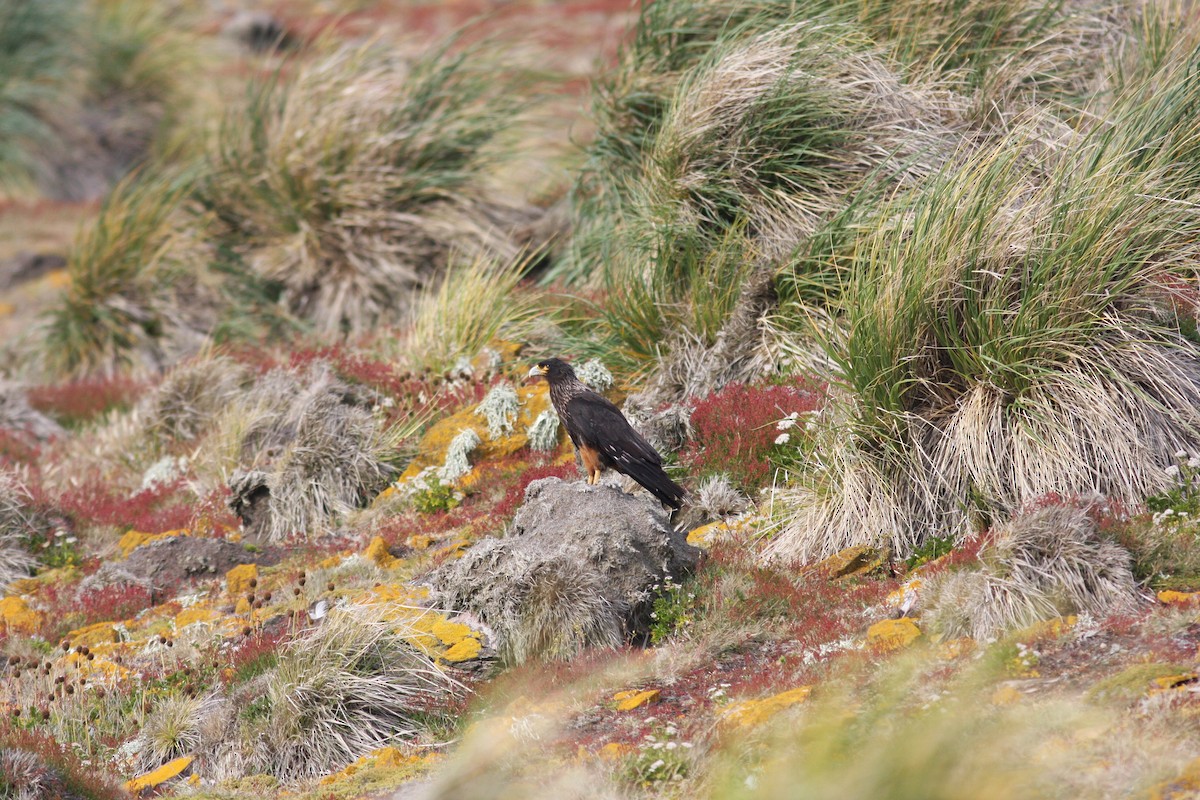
769;31;1200;560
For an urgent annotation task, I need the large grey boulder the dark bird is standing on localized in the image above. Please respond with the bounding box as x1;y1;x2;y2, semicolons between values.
428;477;700;663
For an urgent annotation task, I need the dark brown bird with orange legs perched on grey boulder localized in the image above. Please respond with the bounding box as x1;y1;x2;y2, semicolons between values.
529;359;684;509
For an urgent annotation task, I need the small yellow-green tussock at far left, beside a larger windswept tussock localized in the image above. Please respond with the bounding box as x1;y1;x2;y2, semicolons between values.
38;175;217;375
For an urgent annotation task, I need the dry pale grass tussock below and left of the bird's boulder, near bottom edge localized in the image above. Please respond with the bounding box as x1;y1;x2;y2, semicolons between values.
262;606;462;781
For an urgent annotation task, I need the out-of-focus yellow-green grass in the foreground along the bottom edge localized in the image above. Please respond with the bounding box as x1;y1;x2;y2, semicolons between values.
709;662;1189;800
